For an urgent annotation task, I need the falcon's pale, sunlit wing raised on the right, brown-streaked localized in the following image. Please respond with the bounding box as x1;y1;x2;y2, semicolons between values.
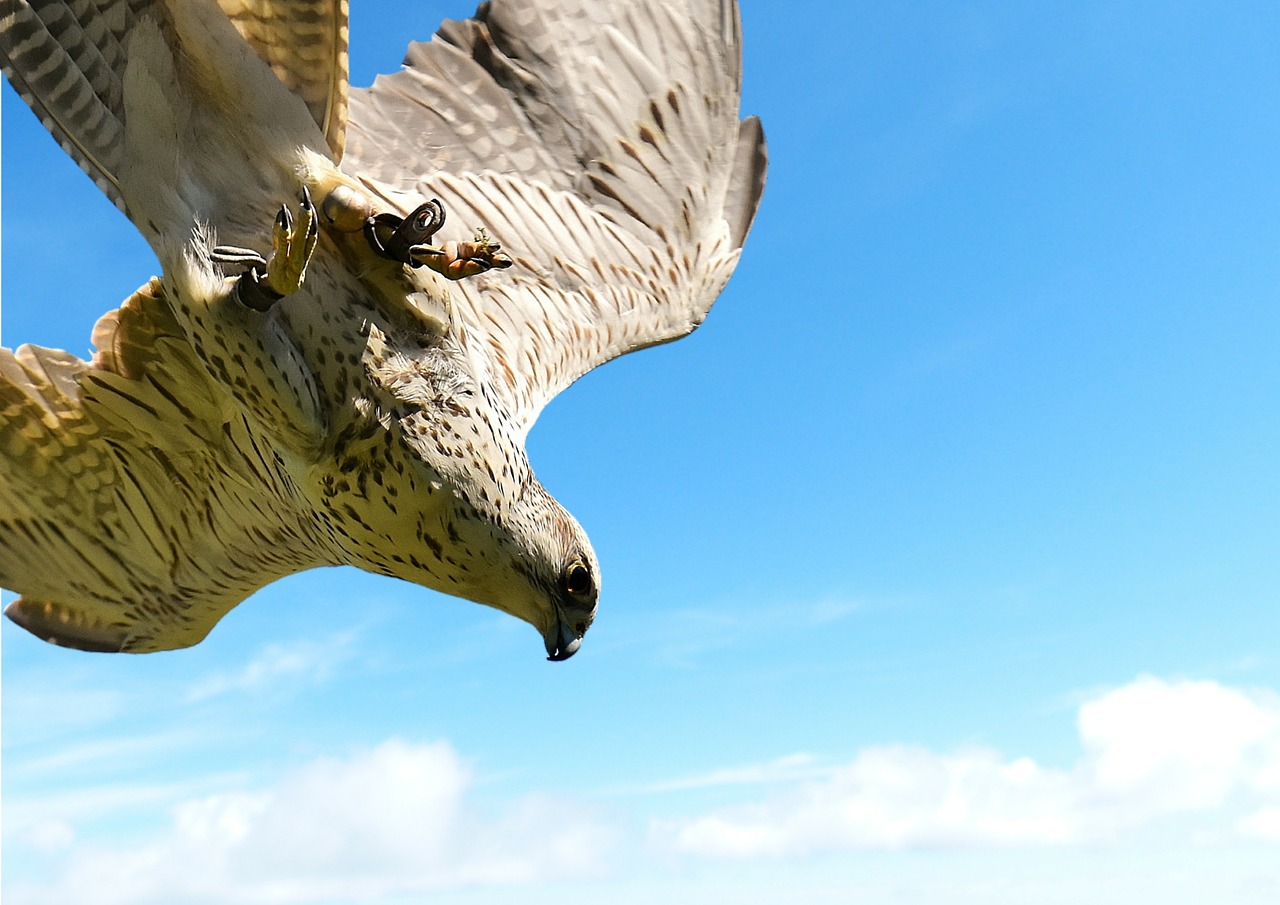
343;0;765;429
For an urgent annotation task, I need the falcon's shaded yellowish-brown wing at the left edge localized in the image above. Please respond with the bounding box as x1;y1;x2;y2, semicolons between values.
0;282;323;653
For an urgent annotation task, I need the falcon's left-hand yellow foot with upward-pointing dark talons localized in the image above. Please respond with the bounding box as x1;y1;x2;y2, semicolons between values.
212;186;320;311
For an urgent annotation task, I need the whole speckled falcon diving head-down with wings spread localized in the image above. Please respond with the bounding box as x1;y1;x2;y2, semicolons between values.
0;0;765;659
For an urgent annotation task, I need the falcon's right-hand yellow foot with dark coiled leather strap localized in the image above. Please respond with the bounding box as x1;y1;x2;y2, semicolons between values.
365;198;512;280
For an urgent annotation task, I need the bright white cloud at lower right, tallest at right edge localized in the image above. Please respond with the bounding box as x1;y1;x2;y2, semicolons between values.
654;677;1280;858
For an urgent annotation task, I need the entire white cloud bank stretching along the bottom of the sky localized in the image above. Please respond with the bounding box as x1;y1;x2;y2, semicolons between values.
5;676;1280;905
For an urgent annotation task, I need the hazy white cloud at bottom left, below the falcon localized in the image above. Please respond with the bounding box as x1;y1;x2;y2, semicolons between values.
5;740;611;905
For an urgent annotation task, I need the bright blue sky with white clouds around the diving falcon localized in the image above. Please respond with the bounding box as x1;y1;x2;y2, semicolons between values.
3;0;1280;905
